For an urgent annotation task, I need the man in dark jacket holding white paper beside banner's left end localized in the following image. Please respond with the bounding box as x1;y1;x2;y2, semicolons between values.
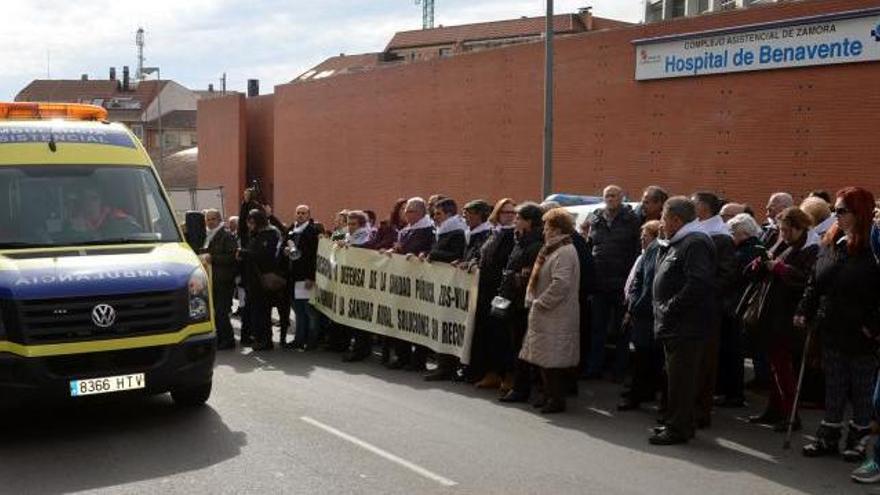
285;205;318;349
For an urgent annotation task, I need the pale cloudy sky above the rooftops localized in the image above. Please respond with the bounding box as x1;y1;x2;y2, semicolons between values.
0;0;644;101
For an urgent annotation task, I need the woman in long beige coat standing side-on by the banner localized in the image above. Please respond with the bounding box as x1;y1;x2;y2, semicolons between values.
519;208;580;414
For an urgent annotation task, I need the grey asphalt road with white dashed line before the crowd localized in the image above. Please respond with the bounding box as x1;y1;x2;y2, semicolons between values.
0;340;880;494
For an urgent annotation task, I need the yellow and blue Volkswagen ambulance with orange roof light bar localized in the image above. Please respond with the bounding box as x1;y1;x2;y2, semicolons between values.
0;103;216;407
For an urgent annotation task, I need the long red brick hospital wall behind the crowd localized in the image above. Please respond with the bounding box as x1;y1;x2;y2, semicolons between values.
198;0;880;225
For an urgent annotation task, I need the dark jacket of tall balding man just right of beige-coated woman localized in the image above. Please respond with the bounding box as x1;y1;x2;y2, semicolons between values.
587;205;641;294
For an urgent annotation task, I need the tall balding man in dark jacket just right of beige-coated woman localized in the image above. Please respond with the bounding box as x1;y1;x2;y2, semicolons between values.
586;186;641;378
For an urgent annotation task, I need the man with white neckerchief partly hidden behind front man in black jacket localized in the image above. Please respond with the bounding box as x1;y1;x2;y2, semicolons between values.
691;192;739;428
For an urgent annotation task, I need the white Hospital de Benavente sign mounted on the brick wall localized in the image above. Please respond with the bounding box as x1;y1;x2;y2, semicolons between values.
633;9;880;81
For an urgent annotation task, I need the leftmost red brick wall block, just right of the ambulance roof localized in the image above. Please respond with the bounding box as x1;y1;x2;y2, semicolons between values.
196;95;247;215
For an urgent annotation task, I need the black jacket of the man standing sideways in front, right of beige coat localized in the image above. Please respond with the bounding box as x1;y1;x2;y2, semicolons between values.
654;228;718;339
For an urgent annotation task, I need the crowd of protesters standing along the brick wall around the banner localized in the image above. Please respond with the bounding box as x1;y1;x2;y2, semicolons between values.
196;185;880;483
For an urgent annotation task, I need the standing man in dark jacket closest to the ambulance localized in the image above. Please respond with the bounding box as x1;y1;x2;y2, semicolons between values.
201;209;238;350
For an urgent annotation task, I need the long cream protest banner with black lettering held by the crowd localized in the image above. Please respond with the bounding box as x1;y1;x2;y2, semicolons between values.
312;239;477;363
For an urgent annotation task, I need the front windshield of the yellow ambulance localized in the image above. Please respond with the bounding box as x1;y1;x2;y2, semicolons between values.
0;165;180;249
